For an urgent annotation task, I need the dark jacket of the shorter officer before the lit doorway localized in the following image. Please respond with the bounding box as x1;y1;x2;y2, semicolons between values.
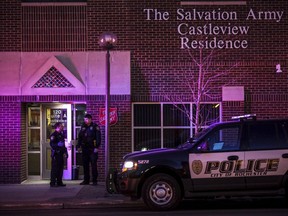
50;131;67;156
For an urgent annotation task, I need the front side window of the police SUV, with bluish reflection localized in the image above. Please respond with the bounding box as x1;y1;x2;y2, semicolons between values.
198;126;240;152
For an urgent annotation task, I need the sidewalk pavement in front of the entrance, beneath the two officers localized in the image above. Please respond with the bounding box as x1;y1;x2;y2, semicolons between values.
0;180;143;210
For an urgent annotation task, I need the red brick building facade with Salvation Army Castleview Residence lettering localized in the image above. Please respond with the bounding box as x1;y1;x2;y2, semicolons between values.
0;0;288;183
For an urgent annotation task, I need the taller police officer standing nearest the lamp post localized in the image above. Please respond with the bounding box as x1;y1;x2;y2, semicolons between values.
77;114;101;185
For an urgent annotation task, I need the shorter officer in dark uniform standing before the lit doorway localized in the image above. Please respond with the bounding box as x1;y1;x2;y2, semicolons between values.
50;122;68;187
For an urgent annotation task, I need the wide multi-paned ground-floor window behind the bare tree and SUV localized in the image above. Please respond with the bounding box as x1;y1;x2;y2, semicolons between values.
132;103;220;151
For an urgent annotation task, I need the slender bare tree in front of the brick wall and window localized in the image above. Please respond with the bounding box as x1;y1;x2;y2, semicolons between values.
166;49;238;134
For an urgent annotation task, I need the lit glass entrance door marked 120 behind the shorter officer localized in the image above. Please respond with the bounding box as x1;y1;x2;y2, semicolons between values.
42;104;72;180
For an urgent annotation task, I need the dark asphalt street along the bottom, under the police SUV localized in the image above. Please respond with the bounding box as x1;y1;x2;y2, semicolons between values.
0;198;288;216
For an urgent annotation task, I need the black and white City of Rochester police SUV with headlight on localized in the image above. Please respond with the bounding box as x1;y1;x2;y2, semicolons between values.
110;115;288;210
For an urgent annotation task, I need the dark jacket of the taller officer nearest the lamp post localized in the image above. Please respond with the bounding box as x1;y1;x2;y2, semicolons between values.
77;122;101;149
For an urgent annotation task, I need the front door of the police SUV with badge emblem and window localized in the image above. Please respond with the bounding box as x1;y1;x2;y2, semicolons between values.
189;125;245;191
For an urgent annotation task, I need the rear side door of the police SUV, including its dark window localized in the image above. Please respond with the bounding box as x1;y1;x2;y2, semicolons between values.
244;121;288;190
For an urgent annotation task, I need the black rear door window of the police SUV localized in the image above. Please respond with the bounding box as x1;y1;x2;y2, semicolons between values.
247;122;279;150
